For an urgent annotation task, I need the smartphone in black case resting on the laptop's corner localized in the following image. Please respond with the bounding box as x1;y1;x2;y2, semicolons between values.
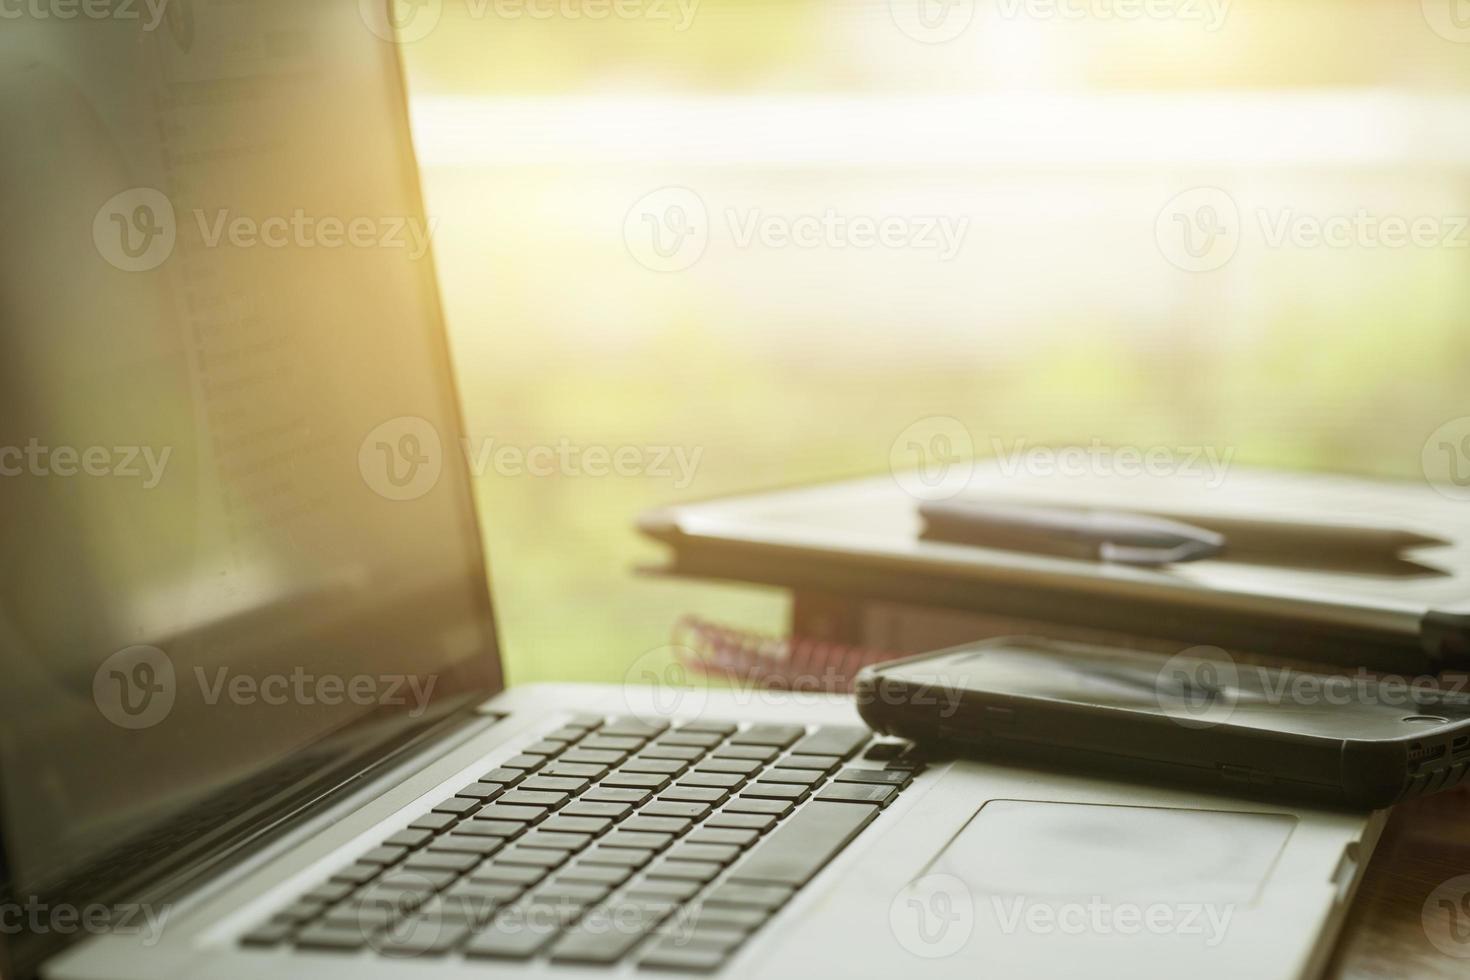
854;638;1470;808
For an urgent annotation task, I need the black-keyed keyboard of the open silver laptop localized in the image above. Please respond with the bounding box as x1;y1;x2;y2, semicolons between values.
241;716;922;973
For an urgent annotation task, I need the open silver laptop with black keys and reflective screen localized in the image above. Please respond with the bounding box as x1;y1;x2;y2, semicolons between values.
0;0;1382;980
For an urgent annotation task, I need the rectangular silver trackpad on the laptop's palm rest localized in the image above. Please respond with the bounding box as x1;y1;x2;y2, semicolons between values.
926;799;1297;911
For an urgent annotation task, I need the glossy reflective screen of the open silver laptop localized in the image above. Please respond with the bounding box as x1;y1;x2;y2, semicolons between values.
0;0;500;934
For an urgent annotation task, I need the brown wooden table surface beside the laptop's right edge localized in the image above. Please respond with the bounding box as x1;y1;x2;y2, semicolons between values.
1324;786;1470;980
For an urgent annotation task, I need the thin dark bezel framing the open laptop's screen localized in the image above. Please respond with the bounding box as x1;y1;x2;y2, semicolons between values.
0;13;504;977
